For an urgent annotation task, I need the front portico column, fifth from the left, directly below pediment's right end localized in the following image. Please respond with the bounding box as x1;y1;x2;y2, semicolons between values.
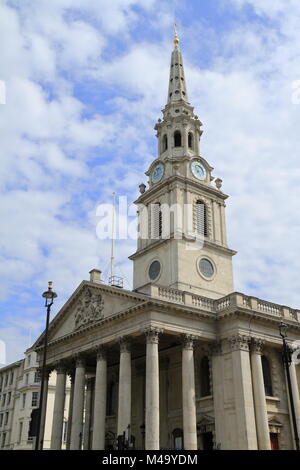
145;328;161;450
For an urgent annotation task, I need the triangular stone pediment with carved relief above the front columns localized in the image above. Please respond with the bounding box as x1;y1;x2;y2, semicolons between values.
33;281;147;348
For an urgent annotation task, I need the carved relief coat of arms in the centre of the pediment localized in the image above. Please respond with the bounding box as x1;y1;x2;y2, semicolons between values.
74;287;104;330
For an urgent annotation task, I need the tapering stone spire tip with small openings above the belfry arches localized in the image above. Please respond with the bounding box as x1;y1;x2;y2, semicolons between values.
168;25;188;105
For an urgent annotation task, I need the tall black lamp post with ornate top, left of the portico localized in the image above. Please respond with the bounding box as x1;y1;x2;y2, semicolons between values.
35;281;57;450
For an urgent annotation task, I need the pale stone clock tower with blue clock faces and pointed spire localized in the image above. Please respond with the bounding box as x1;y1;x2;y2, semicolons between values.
130;33;236;299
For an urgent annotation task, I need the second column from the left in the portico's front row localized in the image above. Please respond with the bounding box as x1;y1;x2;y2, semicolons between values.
70;357;85;450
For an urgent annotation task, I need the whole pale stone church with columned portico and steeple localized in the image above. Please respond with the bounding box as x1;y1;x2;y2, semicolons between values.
33;31;300;450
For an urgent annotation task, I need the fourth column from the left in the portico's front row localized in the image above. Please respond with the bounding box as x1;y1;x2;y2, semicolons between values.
118;338;131;436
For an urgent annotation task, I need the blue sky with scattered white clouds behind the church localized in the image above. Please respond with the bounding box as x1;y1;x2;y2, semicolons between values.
0;0;300;362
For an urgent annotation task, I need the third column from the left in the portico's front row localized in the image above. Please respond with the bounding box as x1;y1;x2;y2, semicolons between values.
93;347;107;450
